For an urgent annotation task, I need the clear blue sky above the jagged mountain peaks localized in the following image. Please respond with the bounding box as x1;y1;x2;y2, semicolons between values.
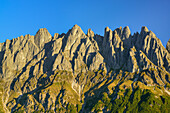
0;0;170;46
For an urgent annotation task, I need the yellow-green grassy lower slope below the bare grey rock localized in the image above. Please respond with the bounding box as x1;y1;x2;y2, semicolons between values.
3;70;170;113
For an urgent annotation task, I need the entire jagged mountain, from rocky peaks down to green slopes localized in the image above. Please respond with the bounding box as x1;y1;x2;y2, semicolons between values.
0;25;170;113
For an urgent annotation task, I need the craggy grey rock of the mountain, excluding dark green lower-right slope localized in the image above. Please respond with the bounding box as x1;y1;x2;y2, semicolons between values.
0;25;170;112
